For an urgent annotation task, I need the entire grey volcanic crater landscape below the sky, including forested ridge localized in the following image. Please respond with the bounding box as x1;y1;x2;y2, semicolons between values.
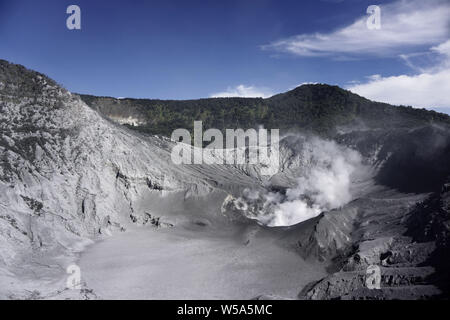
0;60;450;299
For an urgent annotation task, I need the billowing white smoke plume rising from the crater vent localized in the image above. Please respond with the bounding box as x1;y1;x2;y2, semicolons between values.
232;137;368;226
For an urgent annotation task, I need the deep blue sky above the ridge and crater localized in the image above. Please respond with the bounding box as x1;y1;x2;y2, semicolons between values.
0;0;450;111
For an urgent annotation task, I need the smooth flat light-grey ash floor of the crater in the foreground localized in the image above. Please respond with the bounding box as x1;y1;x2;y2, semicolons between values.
79;225;326;299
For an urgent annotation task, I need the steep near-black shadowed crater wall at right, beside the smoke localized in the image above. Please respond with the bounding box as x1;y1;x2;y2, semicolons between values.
335;122;450;193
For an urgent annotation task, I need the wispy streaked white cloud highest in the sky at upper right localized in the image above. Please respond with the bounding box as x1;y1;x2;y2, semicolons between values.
263;0;450;58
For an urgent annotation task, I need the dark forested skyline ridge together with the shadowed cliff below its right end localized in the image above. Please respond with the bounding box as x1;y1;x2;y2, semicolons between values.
81;78;450;192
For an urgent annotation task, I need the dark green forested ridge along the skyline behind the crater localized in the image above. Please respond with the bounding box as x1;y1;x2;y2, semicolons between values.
80;84;450;136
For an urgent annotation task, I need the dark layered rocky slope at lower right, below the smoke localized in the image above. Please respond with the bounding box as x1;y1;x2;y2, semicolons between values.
290;180;450;300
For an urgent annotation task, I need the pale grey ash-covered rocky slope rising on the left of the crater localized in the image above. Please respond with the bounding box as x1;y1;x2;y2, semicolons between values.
0;61;266;298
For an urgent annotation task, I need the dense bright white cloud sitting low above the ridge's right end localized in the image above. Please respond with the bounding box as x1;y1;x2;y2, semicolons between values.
347;40;450;113
